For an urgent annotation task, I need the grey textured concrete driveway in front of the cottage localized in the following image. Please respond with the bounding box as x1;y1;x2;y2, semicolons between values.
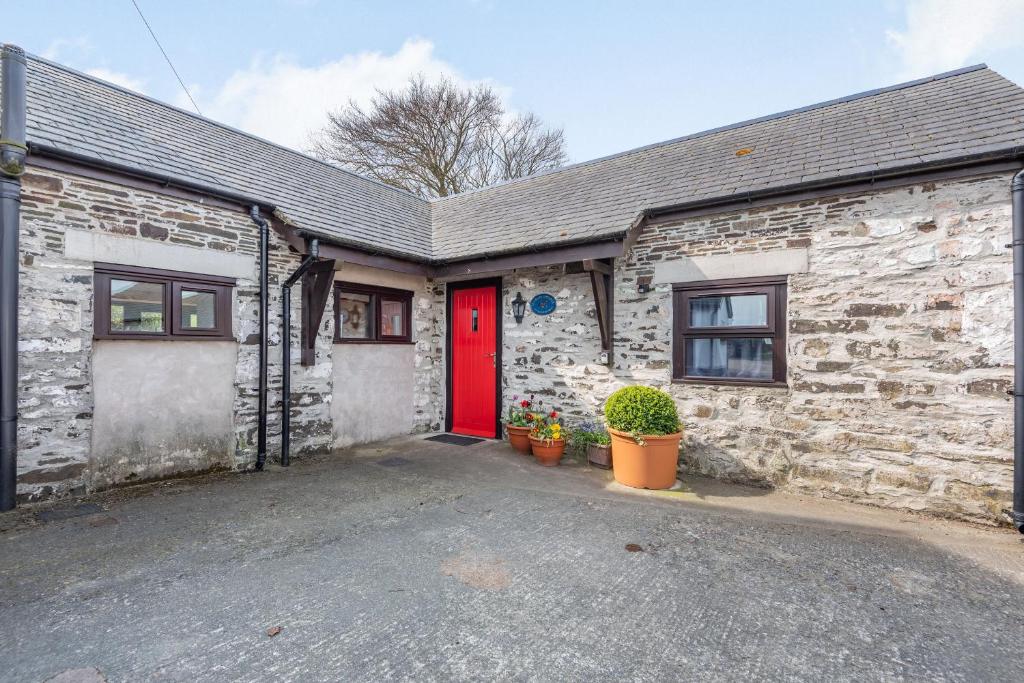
0;438;1024;681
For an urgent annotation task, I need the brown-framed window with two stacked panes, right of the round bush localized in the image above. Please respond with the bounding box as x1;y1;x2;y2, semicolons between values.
672;276;786;386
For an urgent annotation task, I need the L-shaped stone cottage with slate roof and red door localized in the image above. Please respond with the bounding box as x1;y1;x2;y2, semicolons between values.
0;46;1024;522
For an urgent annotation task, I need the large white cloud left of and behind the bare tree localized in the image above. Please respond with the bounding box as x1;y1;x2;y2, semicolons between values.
194;40;493;150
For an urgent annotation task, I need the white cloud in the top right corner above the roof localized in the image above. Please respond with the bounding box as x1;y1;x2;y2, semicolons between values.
886;0;1024;80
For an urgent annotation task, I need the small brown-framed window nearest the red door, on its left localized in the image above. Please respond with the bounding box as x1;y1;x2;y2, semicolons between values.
334;283;413;344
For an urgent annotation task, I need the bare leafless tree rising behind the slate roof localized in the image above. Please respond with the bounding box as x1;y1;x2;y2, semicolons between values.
310;76;566;197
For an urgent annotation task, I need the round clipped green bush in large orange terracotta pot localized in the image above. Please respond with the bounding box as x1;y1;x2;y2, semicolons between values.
604;386;683;488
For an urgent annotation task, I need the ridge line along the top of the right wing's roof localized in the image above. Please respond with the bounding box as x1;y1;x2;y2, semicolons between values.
428;62;988;204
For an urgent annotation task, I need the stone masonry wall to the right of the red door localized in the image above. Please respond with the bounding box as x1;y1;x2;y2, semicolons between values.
452;174;1013;522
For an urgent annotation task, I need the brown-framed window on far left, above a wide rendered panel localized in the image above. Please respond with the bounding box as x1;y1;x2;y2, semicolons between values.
93;263;234;341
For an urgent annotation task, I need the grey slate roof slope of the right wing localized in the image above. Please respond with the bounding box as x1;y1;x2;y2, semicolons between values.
432;65;1024;259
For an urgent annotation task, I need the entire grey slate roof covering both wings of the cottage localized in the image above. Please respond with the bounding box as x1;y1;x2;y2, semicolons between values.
9;57;1024;261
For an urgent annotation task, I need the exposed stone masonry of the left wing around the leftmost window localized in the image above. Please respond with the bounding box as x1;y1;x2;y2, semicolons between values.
18;167;332;500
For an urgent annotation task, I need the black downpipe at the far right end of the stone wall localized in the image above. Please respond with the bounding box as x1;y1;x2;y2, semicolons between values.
1010;170;1024;533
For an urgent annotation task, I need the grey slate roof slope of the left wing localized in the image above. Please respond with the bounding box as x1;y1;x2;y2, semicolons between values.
20;56;430;260
